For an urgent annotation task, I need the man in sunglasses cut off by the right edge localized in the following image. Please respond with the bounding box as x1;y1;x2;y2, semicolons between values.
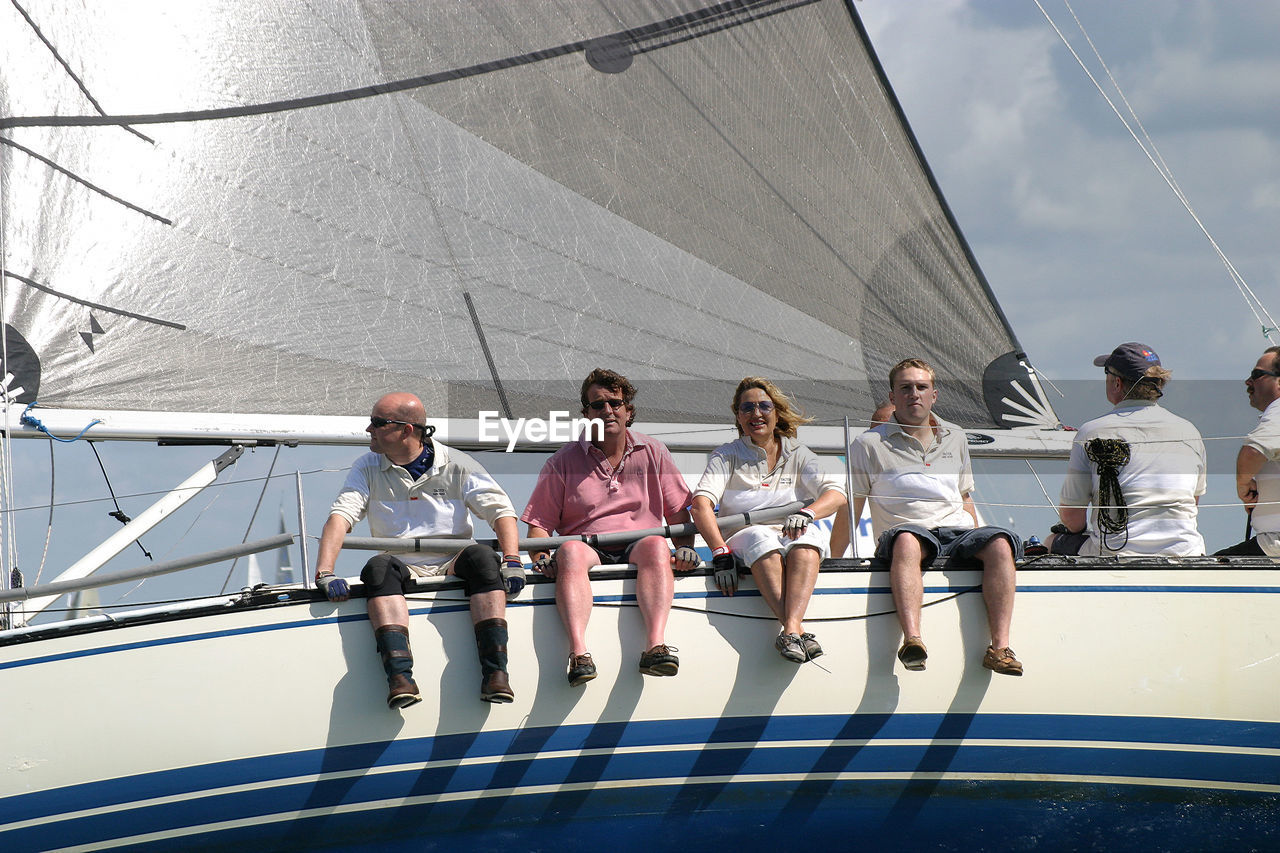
1213;347;1280;557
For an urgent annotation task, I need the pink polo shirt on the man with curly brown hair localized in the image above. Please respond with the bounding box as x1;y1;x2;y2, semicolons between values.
520;429;692;535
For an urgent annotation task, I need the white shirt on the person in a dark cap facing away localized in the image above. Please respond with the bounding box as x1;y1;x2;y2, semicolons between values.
1059;400;1208;557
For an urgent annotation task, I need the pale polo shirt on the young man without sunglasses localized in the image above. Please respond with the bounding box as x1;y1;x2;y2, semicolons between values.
849;415;974;537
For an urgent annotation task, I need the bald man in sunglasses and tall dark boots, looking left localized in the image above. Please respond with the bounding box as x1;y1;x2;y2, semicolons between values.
316;393;524;708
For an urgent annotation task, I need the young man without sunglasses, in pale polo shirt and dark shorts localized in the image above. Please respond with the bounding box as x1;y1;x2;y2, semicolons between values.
855;359;1023;675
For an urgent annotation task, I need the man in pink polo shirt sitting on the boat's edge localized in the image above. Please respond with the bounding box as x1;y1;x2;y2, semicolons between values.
520;368;699;686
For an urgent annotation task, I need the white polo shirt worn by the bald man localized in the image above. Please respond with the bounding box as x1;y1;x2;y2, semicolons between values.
329;442;516;566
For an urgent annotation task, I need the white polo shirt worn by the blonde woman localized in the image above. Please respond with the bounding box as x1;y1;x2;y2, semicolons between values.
694;437;845;529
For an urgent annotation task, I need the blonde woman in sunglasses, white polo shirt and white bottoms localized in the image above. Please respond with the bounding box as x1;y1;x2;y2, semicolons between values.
692;377;845;663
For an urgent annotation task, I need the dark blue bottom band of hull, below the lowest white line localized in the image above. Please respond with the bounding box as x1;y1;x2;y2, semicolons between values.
32;781;1280;853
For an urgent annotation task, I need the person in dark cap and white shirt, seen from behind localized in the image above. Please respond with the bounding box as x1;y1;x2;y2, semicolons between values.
1044;342;1206;557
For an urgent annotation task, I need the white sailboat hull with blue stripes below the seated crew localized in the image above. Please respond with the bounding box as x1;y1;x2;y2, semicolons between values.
0;560;1280;850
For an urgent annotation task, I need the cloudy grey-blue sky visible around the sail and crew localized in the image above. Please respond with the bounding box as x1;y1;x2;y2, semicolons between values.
2;0;1280;625
